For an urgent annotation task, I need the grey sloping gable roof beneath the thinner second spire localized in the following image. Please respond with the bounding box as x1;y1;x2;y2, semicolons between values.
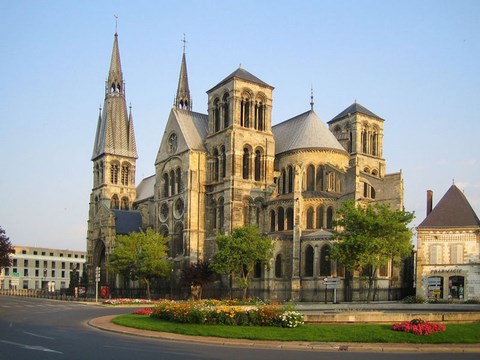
172;108;208;150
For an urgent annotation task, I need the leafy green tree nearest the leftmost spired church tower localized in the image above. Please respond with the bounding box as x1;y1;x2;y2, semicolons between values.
107;228;172;299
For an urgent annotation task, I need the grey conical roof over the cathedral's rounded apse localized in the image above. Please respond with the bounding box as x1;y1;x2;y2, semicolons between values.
272;110;345;154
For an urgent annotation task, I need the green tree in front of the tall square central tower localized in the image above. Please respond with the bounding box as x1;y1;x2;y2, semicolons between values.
211;225;274;299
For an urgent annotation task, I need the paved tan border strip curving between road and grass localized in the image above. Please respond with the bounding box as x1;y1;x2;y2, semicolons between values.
88;315;480;353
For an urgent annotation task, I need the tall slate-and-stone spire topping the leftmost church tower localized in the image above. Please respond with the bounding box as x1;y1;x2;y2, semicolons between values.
92;33;138;160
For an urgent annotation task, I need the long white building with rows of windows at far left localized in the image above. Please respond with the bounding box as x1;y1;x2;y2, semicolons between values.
0;246;86;292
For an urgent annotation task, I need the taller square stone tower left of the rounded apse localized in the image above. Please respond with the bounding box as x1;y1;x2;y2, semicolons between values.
205;67;275;237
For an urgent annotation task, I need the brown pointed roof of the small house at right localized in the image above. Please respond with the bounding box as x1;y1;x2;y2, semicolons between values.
418;185;480;228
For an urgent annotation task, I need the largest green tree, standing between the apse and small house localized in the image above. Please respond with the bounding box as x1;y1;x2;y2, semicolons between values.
330;201;414;302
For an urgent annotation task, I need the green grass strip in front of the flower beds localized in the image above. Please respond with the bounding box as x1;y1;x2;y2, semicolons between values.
112;314;480;344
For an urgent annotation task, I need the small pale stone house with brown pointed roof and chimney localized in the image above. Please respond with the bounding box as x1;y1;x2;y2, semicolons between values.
416;185;480;300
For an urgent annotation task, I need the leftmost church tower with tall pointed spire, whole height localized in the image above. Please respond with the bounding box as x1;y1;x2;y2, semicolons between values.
87;33;138;278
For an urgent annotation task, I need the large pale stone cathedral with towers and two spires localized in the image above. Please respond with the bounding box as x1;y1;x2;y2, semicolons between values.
87;34;404;301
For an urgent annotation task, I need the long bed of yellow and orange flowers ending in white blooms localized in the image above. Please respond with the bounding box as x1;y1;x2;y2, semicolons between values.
150;300;303;327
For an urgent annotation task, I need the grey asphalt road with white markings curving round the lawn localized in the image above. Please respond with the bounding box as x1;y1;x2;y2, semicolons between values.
0;296;478;360
